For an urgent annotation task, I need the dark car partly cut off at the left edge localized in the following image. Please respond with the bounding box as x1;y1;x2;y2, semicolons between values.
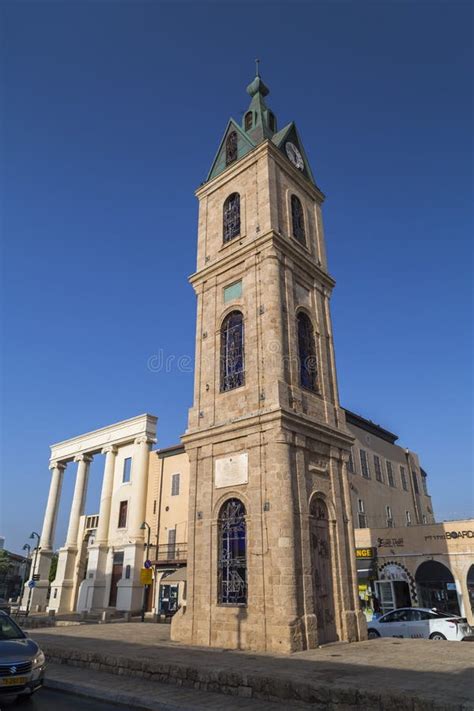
0;611;46;698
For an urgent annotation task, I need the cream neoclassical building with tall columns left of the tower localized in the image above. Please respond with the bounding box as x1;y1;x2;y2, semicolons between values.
22;415;157;612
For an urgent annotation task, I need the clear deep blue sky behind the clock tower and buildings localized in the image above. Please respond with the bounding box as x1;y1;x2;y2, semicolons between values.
0;0;473;550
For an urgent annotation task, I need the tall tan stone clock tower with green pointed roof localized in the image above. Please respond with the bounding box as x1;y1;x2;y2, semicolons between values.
171;71;365;652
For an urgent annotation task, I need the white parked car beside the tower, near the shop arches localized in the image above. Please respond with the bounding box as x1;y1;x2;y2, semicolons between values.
367;607;474;642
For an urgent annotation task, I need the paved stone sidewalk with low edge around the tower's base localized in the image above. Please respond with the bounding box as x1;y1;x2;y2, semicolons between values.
31;623;474;711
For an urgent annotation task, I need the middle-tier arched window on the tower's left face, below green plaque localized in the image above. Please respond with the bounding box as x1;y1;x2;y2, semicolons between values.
221;311;245;392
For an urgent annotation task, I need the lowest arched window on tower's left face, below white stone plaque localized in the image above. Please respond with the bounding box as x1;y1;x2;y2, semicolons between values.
218;499;247;605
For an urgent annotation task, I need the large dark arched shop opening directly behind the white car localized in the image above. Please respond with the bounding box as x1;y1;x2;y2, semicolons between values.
415;560;461;615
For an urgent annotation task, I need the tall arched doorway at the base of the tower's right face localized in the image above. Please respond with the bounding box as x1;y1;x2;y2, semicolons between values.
309;498;338;644
